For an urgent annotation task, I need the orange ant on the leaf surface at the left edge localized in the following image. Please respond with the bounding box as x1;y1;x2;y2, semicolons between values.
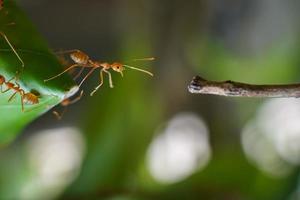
0;75;39;112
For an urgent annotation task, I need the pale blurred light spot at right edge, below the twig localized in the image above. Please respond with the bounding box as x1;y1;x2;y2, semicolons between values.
242;99;300;176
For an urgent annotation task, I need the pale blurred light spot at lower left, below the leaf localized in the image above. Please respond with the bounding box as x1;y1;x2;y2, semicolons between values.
21;127;85;199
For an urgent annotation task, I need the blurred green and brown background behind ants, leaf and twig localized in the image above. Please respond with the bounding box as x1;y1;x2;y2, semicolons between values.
0;0;300;200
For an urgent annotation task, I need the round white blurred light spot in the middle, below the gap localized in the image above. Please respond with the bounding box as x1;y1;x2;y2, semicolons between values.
147;113;211;183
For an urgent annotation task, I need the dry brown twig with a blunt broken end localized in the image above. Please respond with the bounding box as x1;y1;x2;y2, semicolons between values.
188;76;300;98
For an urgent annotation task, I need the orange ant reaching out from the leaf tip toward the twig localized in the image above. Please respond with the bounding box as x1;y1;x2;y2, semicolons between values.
44;50;154;96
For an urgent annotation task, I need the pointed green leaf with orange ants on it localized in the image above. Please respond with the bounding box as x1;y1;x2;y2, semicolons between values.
0;0;78;146
